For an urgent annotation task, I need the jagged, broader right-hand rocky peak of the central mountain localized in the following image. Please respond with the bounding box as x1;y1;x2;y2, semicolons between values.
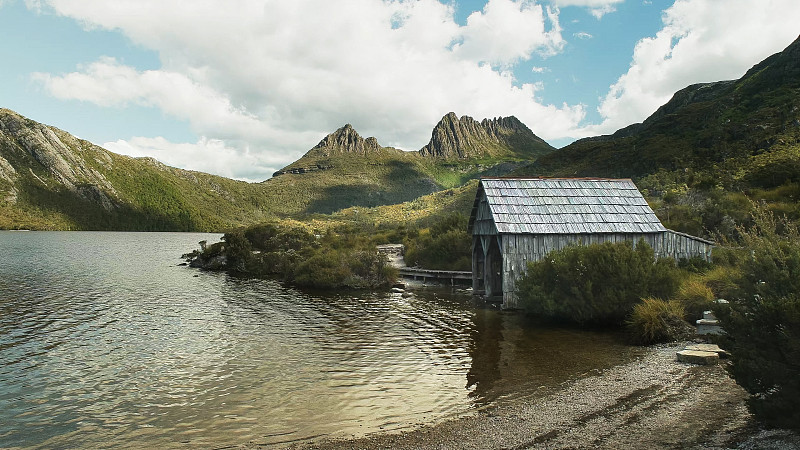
419;112;554;159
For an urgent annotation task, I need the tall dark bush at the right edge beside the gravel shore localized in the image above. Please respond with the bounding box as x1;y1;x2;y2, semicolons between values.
715;208;800;428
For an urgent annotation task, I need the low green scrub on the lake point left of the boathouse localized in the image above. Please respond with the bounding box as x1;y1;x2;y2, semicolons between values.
184;213;471;289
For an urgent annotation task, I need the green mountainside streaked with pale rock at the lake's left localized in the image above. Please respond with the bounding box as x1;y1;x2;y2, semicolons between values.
0;109;274;231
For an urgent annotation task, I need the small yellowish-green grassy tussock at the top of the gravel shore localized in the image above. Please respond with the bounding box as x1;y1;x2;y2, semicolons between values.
627;297;694;345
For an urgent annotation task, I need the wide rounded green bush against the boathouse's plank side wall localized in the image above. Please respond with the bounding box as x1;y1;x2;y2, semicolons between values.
517;241;680;325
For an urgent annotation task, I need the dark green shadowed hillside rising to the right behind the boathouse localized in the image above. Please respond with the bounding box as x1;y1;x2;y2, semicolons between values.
524;35;800;177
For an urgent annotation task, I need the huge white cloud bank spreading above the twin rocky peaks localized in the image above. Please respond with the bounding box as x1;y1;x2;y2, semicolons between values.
35;0;584;177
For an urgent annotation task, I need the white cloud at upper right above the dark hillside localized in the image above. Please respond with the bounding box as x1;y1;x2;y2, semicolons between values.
582;0;800;136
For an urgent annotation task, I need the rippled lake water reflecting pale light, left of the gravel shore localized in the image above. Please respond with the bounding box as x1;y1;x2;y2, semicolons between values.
0;231;637;448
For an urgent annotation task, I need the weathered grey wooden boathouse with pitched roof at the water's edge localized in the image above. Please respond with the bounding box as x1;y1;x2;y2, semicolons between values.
469;178;713;308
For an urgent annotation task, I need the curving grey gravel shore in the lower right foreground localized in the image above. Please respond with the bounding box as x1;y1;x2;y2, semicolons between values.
276;343;800;449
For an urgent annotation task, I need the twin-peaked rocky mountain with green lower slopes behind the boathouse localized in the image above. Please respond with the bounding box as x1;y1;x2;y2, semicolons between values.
264;113;555;215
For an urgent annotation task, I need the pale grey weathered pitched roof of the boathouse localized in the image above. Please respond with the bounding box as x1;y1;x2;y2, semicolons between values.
473;178;666;234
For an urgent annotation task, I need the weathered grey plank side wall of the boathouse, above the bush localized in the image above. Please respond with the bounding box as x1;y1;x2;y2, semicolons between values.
500;231;713;308
